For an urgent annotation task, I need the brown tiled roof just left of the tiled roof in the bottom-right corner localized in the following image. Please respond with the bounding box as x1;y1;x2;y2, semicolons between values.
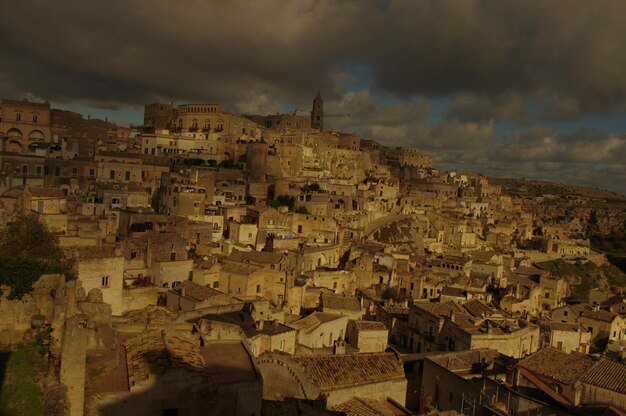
518;348;595;384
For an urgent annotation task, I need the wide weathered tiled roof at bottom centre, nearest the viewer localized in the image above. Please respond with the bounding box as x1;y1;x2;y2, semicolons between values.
293;353;404;390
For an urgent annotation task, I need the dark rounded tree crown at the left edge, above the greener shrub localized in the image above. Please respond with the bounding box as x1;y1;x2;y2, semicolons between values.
0;213;63;260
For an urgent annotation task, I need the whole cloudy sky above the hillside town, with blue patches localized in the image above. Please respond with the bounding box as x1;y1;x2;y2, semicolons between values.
0;0;626;195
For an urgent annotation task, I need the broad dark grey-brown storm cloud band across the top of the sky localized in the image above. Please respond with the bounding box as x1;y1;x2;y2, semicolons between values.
0;0;626;119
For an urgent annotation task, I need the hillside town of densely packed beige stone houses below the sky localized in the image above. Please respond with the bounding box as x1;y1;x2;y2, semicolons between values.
0;93;626;416
